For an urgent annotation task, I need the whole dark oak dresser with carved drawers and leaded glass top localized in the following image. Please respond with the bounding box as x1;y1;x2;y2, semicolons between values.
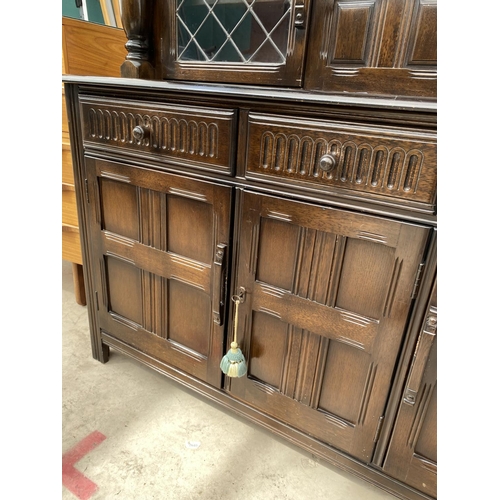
65;0;437;499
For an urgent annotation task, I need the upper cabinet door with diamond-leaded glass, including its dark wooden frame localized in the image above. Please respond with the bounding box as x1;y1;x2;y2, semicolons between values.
159;0;310;86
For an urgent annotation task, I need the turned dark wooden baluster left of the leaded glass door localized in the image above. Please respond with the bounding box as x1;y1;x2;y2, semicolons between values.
120;0;154;80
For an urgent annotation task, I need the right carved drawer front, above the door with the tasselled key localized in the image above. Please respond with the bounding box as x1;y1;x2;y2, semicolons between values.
246;113;437;212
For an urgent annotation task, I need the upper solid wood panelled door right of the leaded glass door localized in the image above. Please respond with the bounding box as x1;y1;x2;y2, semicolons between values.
305;0;437;98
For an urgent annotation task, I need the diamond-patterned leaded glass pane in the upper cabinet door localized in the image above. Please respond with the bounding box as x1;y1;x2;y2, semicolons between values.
176;0;291;64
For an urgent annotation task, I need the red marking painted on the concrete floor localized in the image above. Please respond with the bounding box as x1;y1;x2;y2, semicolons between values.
63;431;106;500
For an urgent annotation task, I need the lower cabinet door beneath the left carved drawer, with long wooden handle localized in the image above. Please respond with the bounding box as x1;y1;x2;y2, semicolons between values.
85;158;231;387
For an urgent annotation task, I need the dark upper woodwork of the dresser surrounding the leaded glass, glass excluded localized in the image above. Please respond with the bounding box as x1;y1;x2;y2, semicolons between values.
122;0;437;99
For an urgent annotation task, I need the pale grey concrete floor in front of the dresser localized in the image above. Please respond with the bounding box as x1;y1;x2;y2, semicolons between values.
62;261;395;500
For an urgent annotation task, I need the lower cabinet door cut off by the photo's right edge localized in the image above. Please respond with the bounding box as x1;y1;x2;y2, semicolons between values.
384;278;437;497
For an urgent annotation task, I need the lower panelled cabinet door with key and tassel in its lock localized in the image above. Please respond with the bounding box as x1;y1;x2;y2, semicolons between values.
227;192;429;462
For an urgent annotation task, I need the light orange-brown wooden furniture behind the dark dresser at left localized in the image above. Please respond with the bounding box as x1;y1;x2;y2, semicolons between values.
62;17;127;305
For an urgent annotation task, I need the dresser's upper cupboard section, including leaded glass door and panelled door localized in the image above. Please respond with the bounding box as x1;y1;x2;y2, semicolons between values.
131;0;437;97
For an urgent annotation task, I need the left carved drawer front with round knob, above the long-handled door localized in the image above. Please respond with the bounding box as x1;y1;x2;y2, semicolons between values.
80;96;236;173
